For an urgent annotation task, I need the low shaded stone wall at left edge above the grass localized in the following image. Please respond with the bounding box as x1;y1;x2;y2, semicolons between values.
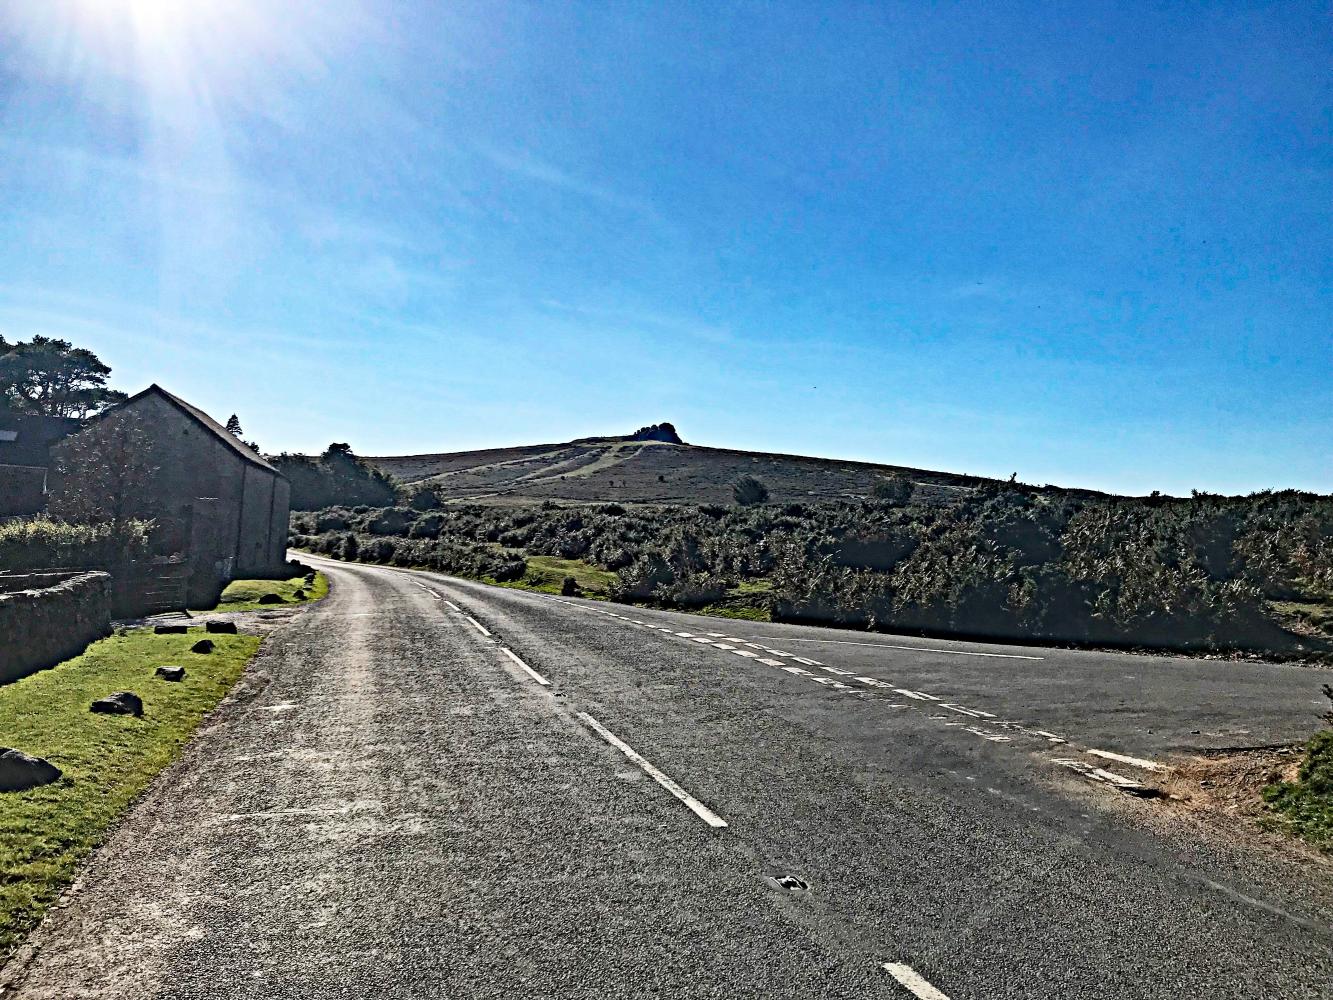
0;572;111;684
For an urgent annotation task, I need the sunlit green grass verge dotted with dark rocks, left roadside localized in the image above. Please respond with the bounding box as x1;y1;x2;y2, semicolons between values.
0;629;260;963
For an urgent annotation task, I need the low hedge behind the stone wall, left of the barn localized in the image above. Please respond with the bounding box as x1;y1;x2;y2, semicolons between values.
0;517;152;571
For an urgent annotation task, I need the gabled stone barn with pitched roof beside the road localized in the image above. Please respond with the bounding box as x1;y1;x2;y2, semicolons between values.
52;385;291;608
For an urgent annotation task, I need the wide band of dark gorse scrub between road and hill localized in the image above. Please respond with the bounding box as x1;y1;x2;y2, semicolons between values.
292;480;1333;659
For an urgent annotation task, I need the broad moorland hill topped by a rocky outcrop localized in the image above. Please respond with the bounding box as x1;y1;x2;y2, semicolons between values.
367;424;1094;504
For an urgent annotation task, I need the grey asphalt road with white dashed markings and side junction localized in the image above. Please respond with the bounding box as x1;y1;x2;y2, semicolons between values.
0;560;1333;1000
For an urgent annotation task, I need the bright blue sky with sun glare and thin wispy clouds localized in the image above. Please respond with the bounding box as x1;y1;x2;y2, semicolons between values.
0;0;1333;492
